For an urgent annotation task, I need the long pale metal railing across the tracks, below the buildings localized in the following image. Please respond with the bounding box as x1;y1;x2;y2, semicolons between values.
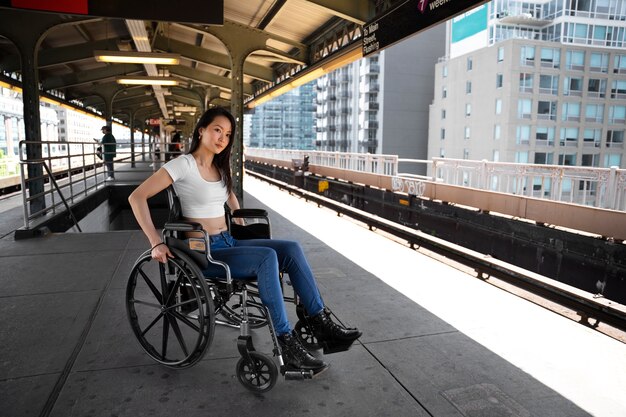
245;148;626;211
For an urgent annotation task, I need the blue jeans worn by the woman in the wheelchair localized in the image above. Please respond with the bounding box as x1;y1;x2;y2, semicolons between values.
203;232;324;335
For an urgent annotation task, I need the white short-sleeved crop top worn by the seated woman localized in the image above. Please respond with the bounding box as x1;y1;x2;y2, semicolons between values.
163;154;228;219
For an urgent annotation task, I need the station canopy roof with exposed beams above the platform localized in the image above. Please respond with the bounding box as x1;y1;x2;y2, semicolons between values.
0;0;386;126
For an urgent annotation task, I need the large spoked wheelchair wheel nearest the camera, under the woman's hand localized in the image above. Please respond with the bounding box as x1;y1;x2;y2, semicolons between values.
126;248;215;368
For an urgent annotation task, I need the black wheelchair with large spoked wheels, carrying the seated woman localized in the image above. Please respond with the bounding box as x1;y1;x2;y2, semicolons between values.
126;186;320;393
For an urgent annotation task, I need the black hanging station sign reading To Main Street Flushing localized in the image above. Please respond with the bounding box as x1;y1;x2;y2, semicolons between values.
363;0;486;57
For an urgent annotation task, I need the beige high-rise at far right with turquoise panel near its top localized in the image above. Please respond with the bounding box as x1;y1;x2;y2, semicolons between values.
428;0;626;168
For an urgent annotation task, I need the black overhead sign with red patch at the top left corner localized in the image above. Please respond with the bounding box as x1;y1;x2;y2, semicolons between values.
0;0;224;25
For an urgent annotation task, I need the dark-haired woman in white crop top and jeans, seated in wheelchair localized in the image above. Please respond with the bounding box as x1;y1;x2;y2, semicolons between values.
128;108;361;373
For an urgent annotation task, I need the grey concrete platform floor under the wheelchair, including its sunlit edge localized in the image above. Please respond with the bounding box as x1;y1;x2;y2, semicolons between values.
0;174;626;417
